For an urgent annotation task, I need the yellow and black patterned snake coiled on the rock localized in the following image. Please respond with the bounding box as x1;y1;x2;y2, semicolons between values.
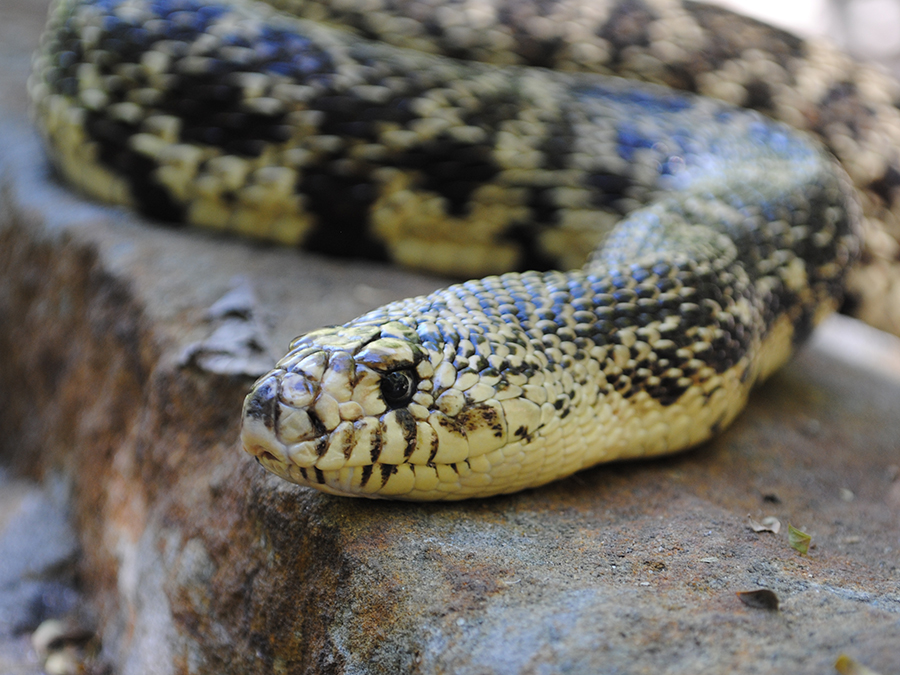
30;0;900;500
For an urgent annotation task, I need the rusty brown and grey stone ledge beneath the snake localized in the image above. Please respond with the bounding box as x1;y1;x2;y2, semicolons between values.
0;0;900;675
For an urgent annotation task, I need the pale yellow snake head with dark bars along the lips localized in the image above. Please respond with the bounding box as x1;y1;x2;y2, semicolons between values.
241;314;541;499
